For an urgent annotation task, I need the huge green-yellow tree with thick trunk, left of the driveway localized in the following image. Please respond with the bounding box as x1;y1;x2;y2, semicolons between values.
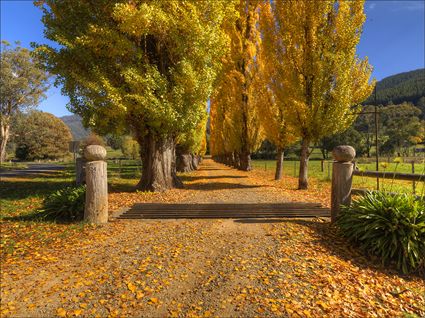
37;0;234;191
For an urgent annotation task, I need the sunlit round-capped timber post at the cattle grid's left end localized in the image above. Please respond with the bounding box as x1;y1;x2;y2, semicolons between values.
84;145;108;224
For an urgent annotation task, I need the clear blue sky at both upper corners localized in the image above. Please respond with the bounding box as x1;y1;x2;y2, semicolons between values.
0;0;425;116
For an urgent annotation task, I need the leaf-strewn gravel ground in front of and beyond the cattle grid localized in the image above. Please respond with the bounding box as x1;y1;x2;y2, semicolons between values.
1;160;425;317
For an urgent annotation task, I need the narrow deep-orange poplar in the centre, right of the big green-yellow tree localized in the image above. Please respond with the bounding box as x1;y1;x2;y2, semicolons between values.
211;0;262;171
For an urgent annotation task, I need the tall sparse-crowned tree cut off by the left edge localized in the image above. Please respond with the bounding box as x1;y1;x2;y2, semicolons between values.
0;41;48;163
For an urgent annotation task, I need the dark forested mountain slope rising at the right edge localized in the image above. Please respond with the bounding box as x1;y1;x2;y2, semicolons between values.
364;68;425;105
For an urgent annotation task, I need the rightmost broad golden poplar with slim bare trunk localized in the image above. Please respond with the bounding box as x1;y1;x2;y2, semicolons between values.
262;0;374;189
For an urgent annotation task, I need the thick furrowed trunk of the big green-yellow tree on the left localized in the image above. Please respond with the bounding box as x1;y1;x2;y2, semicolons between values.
137;133;183;192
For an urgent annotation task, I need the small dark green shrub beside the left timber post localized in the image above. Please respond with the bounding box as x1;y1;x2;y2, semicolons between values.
39;186;86;221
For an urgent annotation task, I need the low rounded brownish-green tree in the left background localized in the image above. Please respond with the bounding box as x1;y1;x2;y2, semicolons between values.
14;111;72;160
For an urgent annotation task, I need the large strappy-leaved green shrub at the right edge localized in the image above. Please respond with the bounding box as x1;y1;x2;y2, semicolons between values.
337;192;425;273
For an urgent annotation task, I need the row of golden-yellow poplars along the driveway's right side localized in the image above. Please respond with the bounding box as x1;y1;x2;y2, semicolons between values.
211;0;374;189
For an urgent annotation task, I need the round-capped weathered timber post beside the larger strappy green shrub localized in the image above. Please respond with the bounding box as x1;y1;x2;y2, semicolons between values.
331;146;356;223
